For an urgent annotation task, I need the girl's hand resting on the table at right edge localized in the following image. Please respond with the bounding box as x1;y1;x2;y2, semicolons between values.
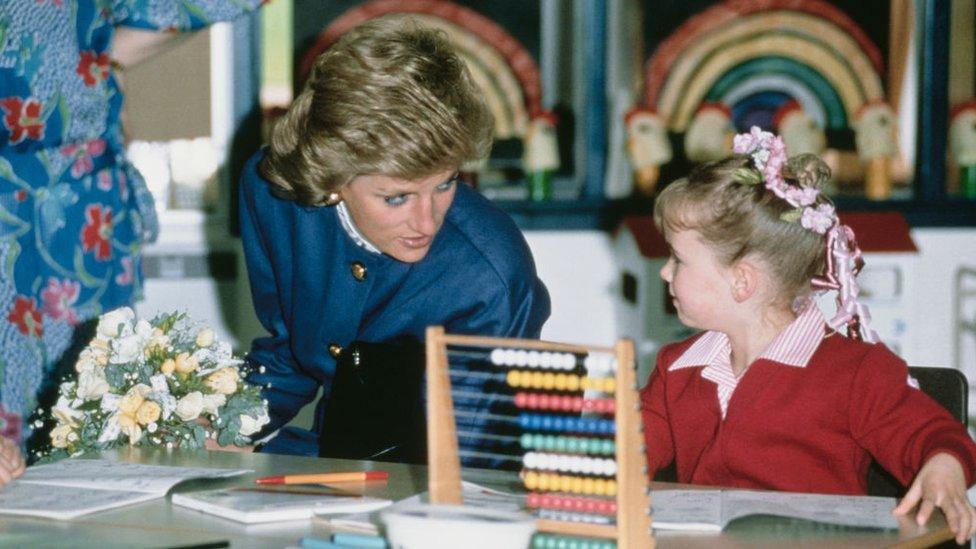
892;454;976;545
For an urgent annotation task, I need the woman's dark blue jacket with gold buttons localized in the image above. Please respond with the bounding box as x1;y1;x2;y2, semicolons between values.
240;151;550;455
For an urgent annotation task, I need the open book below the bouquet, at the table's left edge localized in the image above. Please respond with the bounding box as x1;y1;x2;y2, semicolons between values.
0;459;250;520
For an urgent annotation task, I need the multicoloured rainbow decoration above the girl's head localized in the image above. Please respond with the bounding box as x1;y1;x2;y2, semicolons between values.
643;0;885;132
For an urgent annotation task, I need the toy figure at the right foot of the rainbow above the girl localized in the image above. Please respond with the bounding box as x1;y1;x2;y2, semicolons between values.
854;100;898;200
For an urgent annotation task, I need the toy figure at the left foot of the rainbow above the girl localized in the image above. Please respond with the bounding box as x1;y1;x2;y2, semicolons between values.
624;108;674;197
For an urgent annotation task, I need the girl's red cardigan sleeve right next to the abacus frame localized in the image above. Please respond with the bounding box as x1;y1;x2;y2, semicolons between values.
640;345;674;479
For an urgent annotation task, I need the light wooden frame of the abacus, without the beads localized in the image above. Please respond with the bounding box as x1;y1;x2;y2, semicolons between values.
426;326;654;549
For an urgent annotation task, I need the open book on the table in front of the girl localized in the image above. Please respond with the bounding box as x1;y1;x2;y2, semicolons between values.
651;490;898;532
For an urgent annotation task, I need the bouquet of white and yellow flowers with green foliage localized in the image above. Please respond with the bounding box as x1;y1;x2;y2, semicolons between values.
38;307;269;459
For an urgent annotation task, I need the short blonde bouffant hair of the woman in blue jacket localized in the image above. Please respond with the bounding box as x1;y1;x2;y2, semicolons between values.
259;17;494;206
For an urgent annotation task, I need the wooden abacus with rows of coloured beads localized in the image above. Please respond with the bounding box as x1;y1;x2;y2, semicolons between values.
426;326;654;549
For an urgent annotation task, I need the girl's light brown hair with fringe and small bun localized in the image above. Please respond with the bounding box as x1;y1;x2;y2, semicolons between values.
654;154;831;304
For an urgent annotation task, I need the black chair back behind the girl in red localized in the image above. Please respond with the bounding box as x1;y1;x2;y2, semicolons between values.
868;366;969;497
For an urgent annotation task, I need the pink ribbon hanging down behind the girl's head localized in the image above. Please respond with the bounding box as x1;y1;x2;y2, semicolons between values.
812;222;878;343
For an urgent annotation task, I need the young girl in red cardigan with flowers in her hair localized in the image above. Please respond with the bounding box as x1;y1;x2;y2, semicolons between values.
641;128;976;543
